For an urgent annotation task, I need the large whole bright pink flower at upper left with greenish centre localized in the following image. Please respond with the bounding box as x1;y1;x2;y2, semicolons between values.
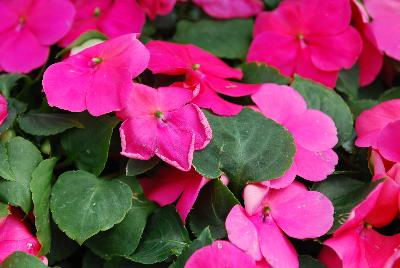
43;34;149;116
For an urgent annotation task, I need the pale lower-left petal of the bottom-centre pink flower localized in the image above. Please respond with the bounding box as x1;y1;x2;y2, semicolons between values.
225;205;262;261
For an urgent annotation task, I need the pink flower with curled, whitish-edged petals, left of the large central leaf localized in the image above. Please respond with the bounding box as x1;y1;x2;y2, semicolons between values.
119;84;212;171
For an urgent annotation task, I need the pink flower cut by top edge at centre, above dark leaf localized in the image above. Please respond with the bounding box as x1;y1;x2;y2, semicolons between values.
193;0;264;19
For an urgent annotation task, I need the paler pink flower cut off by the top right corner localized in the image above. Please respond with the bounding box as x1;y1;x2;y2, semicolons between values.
364;0;400;60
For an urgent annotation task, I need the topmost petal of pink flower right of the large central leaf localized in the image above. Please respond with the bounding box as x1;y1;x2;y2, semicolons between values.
251;84;307;124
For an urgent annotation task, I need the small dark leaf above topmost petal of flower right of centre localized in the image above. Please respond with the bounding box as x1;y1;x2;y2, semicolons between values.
242;62;291;85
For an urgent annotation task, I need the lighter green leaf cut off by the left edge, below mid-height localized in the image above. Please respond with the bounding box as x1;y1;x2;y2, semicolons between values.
0;137;42;213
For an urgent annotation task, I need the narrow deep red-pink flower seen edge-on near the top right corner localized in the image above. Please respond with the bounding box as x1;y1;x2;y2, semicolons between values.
351;0;383;86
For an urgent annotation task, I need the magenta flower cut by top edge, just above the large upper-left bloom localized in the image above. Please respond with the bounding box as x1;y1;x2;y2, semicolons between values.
60;0;145;47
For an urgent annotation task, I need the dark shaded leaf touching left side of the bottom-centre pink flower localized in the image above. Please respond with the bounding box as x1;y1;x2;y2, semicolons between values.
189;180;239;239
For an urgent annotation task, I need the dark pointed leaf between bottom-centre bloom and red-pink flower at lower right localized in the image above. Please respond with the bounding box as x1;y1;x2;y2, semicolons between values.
312;175;382;233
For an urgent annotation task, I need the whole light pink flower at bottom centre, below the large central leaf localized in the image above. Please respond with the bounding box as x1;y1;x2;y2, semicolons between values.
225;182;333;268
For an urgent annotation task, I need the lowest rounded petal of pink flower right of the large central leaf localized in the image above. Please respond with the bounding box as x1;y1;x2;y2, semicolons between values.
294;144;339;181
